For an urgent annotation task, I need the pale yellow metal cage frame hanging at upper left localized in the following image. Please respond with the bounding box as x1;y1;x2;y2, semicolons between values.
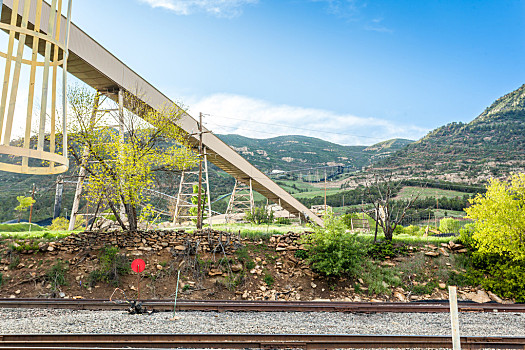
0;0;72;175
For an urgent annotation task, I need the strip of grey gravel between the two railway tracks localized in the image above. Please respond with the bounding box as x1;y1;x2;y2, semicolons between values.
0;309;525;336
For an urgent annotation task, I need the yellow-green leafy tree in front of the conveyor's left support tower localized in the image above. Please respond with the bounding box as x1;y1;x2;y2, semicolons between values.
68;88;198;231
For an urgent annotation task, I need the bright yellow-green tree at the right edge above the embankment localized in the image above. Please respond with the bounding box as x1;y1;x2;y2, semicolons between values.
465;174;525;260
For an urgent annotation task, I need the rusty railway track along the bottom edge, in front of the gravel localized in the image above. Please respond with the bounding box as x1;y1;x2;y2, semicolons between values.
0;334;525;350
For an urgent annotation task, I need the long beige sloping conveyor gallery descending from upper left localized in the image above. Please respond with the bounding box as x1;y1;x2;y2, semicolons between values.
1;0;323;225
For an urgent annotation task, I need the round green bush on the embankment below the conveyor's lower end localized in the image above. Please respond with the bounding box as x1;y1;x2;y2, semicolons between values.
304;214;366;276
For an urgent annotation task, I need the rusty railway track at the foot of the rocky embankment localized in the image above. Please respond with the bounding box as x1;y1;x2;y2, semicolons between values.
0;299;525;313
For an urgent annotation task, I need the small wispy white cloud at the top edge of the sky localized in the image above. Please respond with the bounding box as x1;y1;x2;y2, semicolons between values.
140;0;259;18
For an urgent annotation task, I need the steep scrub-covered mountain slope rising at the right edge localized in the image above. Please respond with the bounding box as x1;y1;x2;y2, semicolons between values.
373;85;525;183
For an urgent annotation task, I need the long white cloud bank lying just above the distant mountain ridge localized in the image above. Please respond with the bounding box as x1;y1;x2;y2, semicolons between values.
183;94;428;145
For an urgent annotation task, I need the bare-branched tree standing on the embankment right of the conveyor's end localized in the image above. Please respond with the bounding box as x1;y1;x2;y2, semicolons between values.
365;173;420;242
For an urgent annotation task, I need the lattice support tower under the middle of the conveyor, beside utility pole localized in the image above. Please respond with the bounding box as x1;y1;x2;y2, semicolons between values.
173;148;212;226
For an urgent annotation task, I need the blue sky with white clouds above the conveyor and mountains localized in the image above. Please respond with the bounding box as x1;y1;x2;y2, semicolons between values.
73;0;525;145
